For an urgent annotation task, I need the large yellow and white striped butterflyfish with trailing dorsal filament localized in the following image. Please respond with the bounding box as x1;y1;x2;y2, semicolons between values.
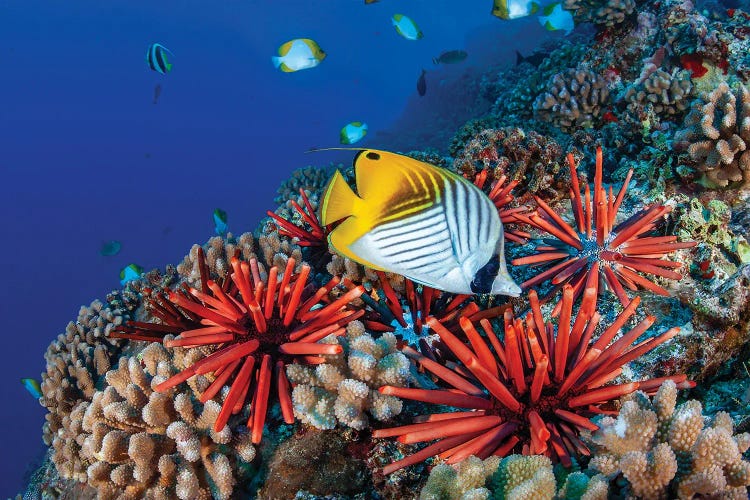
320;149;521;296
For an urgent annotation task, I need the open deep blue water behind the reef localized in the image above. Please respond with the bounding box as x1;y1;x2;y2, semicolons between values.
0;0;560;497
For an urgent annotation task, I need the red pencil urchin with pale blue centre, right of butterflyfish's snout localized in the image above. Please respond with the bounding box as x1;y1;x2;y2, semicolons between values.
512;148;696;314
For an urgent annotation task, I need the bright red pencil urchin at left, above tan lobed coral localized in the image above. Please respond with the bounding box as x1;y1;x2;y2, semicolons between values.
117;252;364;444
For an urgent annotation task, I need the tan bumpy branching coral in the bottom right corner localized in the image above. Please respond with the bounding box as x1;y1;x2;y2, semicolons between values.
589;381;750;499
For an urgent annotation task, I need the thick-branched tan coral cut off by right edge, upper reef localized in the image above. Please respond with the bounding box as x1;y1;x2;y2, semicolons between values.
675;83;750;187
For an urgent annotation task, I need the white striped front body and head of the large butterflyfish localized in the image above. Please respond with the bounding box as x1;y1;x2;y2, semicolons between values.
351;171;520;296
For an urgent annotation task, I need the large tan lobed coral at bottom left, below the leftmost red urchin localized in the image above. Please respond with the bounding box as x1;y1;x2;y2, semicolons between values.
77;344;255;500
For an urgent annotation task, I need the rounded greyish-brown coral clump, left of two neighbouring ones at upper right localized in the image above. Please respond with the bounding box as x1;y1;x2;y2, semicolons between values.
534;65;609;132
